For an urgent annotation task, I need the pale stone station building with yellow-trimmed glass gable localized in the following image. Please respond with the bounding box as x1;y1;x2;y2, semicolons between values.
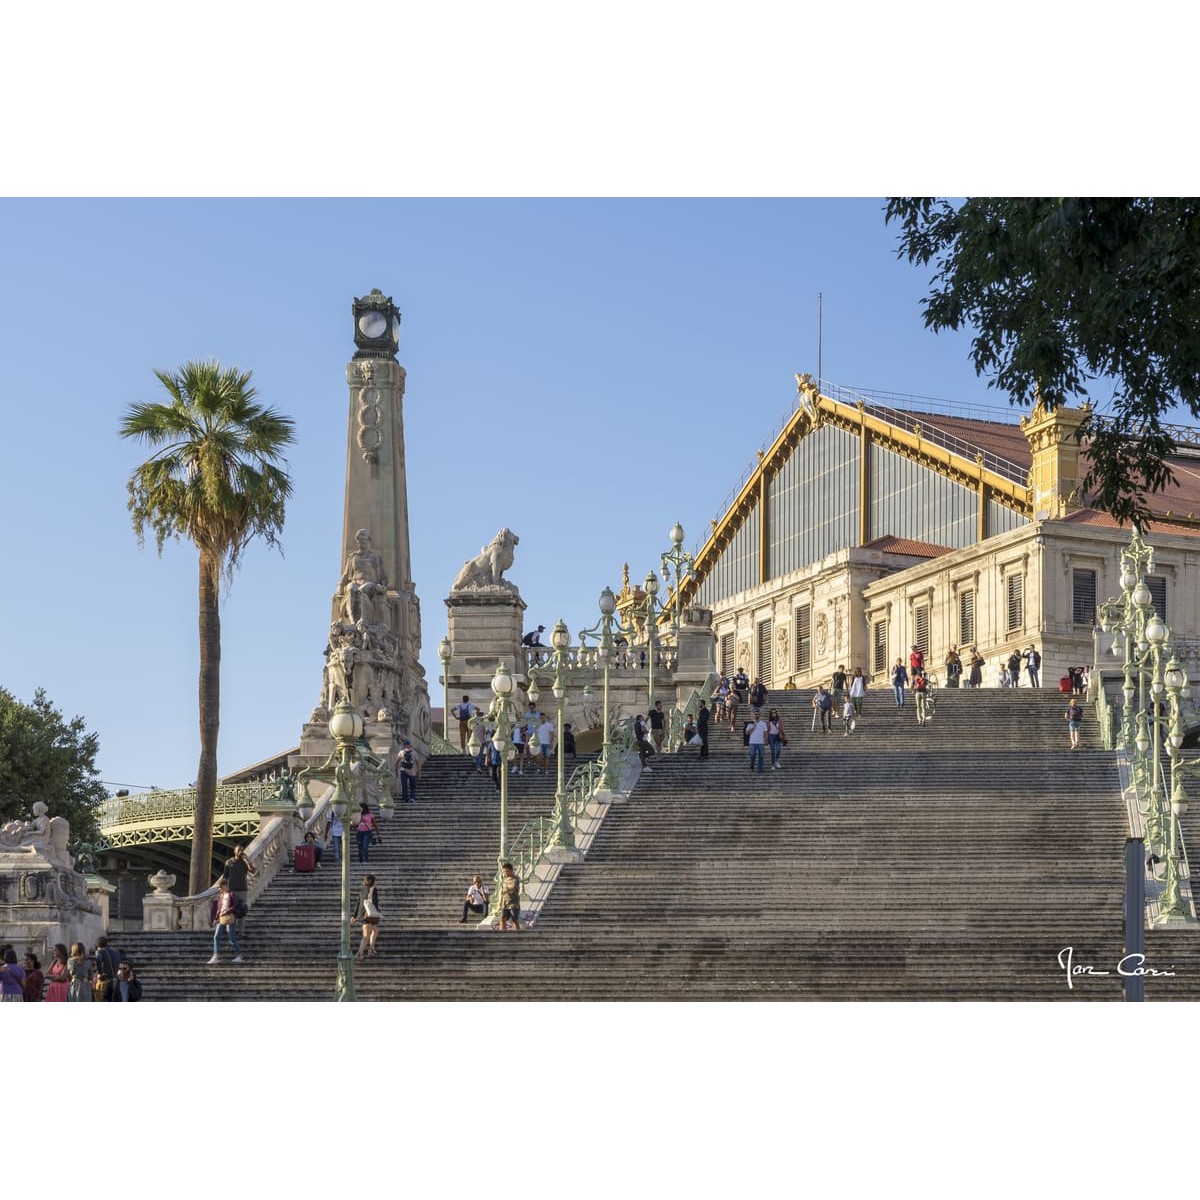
684;376;1200;688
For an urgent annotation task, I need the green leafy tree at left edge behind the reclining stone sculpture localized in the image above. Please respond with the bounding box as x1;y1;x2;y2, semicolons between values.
0;688;107;842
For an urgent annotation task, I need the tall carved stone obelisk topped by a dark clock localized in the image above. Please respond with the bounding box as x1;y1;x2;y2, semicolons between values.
300;288;431;762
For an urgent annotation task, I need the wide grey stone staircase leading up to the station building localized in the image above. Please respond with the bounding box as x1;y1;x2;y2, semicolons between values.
108;689;1200;1001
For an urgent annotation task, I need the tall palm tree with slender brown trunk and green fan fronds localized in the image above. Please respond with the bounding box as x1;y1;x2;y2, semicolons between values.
120;361;294;895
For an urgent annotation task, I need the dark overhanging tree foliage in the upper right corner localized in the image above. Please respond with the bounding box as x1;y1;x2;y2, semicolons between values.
887;197;1200;522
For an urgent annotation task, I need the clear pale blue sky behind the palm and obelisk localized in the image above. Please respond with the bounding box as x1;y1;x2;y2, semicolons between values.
0;199;1007;787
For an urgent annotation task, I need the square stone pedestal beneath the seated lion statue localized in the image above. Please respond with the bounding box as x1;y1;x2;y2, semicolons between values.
445;586;526;691
